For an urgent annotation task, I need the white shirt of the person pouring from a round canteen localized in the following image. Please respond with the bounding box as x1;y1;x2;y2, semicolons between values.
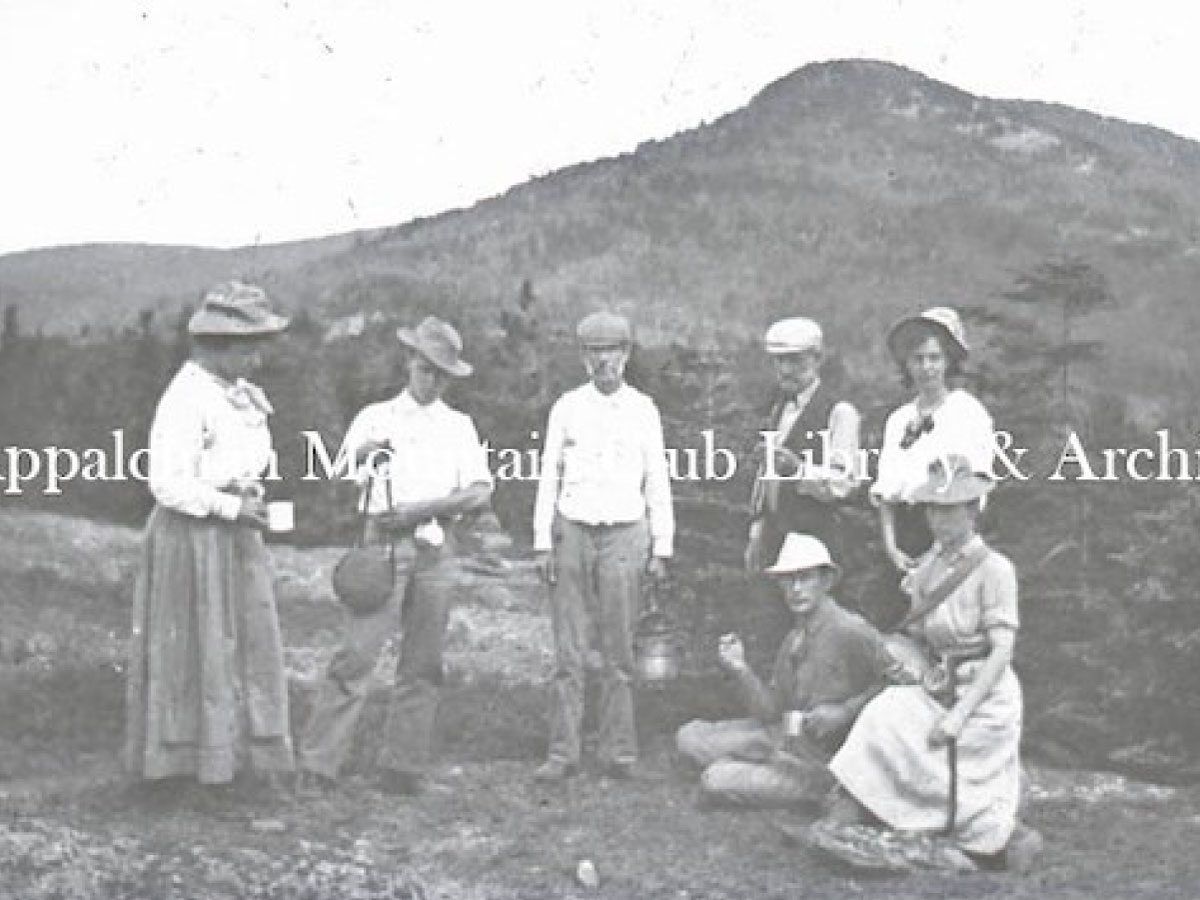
340;389;492;515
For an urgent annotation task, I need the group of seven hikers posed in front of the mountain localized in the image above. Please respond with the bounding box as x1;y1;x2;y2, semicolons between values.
119;282;1042;870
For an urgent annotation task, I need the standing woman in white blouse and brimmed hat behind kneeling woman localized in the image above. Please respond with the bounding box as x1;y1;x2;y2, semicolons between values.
871;306;995;588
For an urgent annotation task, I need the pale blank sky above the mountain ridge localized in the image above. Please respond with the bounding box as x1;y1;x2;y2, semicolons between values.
0;0;1200;253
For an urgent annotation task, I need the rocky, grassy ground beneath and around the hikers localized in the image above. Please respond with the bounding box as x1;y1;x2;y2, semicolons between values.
0;511;1200;900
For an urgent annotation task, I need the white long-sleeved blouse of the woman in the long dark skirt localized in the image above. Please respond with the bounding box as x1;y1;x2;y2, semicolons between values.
150;361;272;521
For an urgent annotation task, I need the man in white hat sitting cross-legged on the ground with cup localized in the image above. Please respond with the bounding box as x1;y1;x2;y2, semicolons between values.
676;533;890;806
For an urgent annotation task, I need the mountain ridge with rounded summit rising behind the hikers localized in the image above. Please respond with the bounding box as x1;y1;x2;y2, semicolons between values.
0;60;1200;400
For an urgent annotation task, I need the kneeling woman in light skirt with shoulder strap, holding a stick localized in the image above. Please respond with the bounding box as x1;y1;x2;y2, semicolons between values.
829;457;1021;856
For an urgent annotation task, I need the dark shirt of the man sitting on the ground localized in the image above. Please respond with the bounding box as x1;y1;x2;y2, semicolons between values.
742;598;890;725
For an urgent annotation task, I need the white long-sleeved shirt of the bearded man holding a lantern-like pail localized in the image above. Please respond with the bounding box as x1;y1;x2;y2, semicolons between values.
533;382;674;557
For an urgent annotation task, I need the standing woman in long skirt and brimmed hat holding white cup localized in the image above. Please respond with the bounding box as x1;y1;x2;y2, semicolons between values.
125;282;293;784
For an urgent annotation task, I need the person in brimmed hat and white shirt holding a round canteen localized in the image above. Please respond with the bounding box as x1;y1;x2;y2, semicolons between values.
299;316;492;793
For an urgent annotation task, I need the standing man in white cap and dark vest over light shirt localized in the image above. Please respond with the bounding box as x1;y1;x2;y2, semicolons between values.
745;317;860;572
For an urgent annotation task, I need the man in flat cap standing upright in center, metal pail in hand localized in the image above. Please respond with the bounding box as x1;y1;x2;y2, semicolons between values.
534;312;674;781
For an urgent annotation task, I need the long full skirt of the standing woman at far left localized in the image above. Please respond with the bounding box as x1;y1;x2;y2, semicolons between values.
125;506;293;784
